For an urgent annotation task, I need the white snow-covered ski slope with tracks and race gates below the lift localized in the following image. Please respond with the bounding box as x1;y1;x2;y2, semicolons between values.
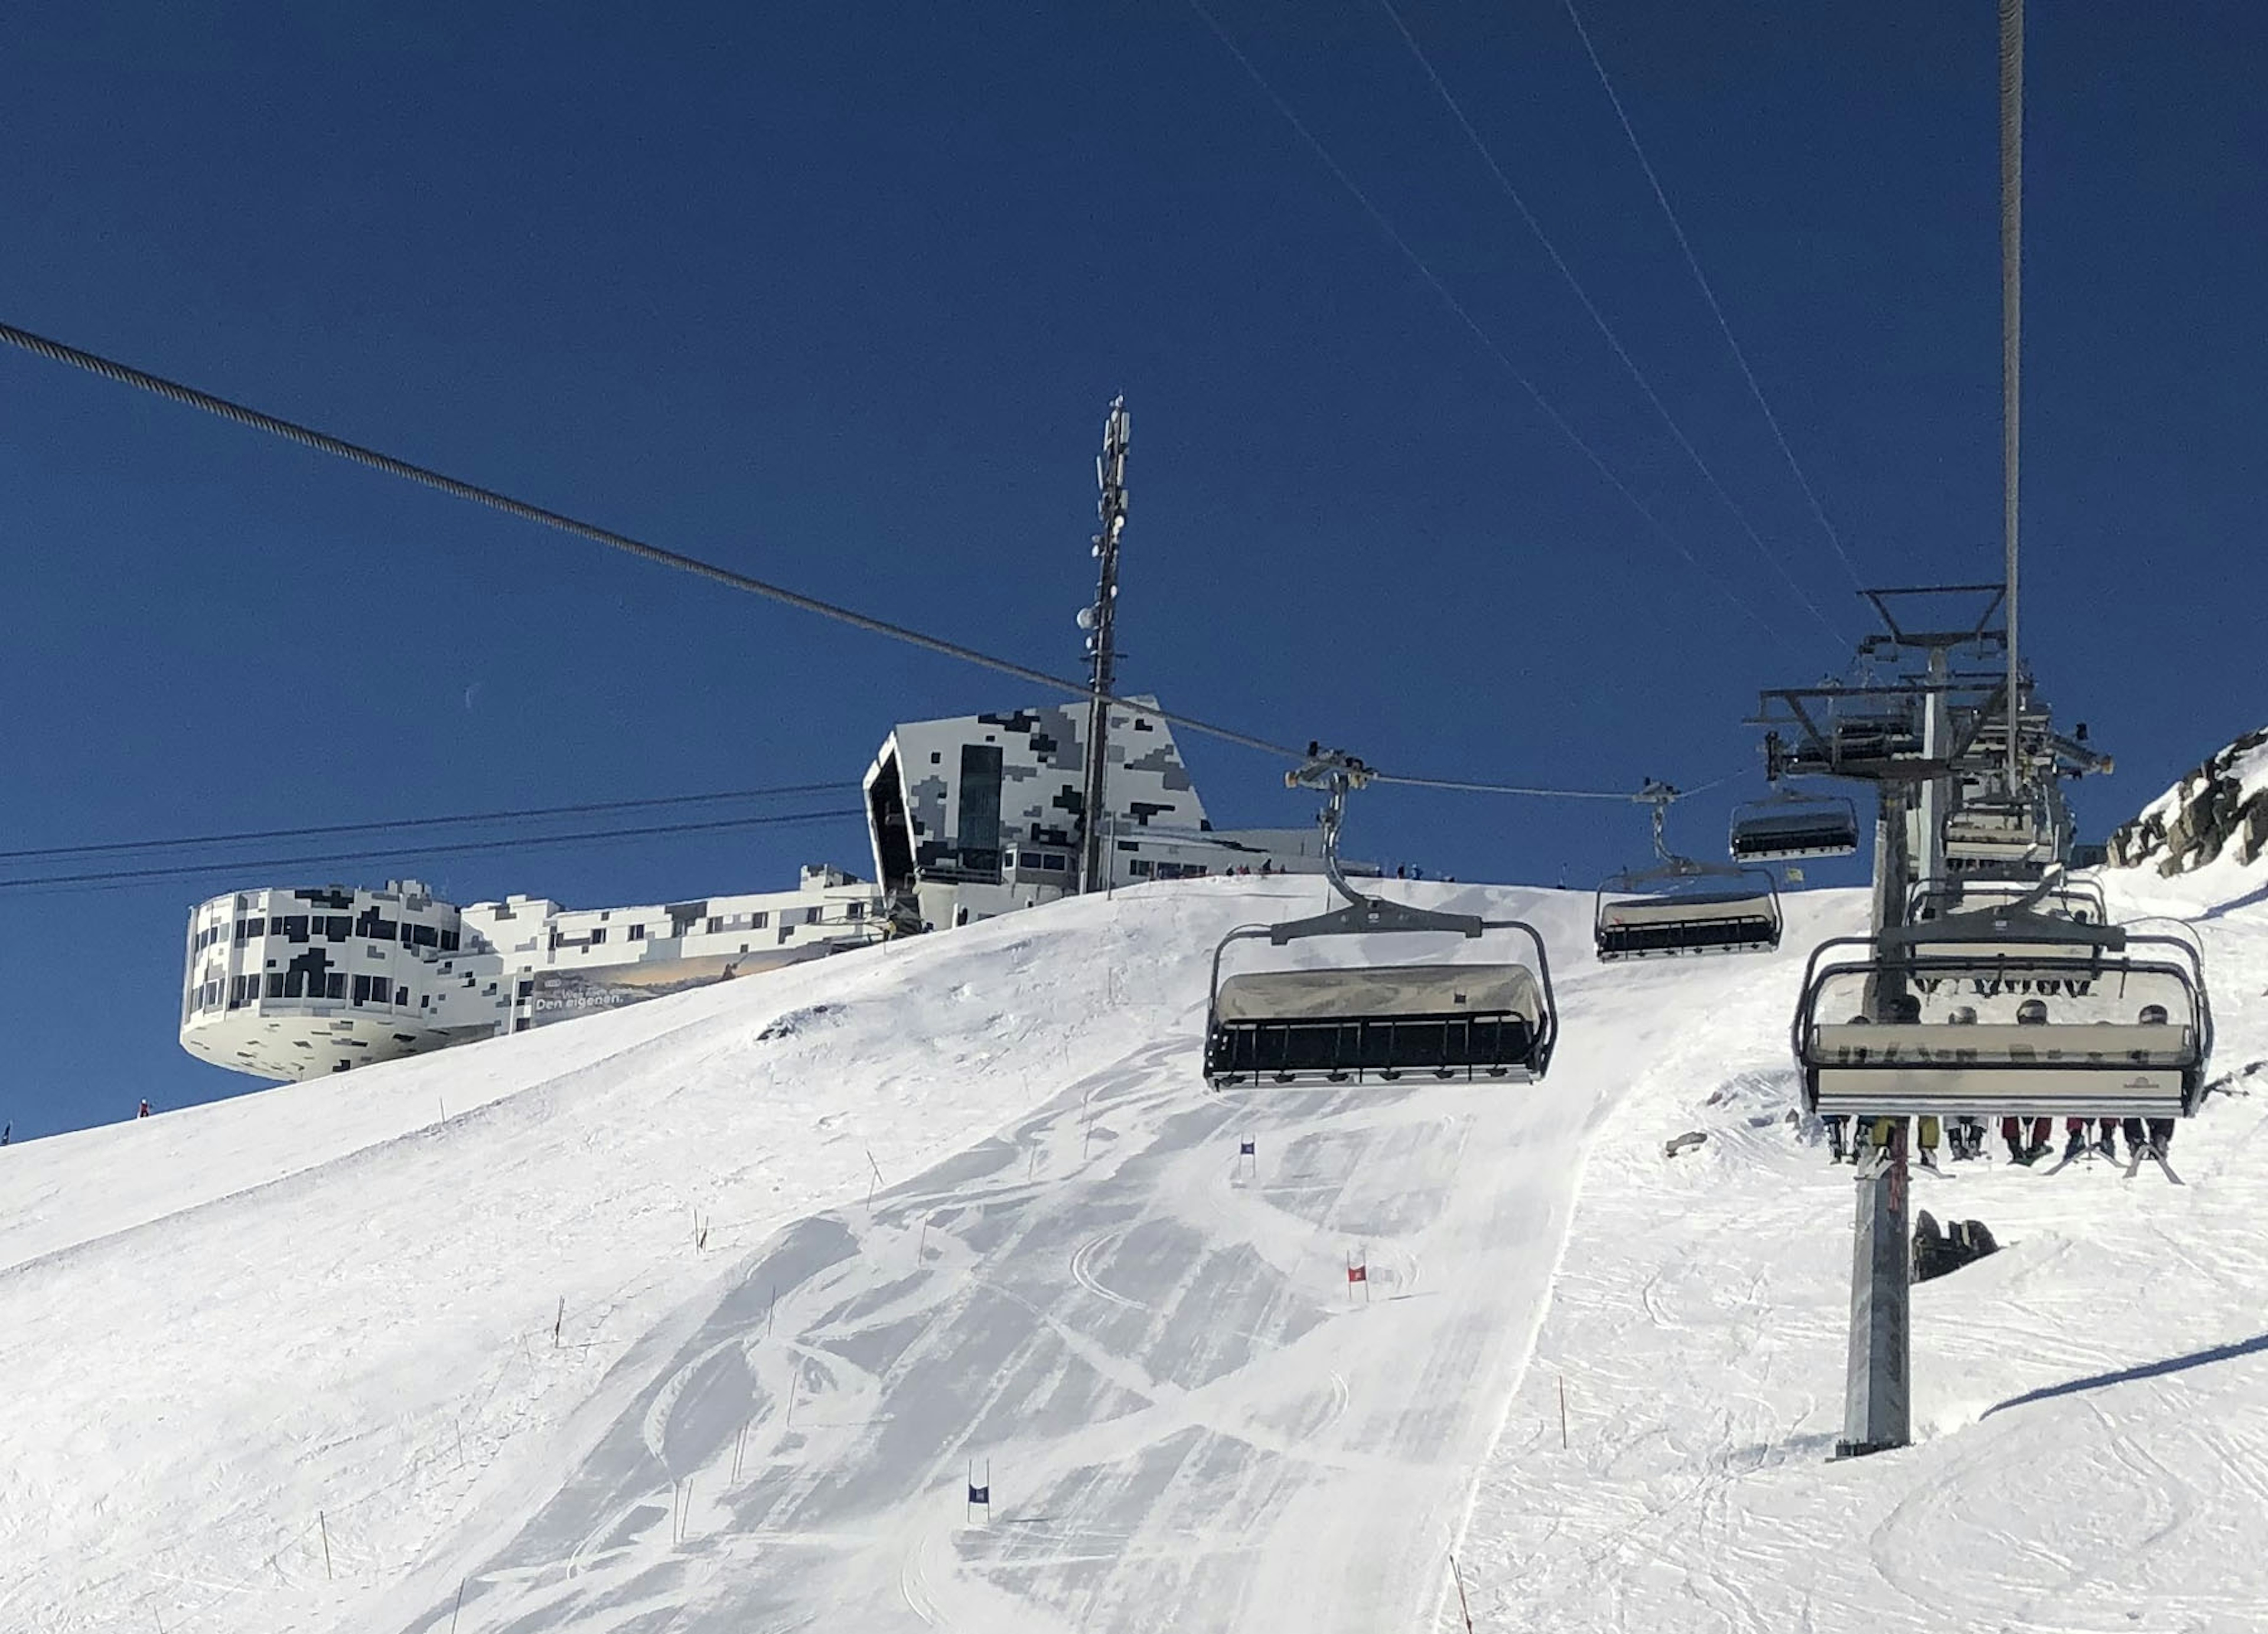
0;870;2268;1634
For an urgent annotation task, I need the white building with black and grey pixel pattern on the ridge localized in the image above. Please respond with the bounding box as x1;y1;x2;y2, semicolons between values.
181;698;1342;1079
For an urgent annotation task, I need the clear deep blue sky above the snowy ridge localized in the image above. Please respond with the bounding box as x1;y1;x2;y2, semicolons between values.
0;0;2268;1138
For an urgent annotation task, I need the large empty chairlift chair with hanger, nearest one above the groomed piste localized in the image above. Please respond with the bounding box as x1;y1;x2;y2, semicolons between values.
1204;750;1558;1088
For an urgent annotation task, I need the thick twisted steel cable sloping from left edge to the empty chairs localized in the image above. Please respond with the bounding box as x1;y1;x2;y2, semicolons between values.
0;317;1732;811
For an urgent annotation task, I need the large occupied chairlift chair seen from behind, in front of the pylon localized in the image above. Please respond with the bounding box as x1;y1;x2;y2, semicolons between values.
1792;909;2214;1117
